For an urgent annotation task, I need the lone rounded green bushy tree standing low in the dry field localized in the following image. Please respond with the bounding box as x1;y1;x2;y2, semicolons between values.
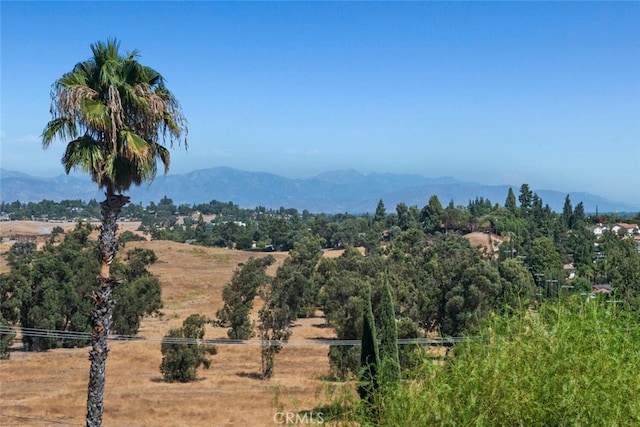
160;314;217;383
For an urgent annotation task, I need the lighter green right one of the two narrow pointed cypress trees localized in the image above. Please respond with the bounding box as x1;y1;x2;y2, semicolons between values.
380;274;400;383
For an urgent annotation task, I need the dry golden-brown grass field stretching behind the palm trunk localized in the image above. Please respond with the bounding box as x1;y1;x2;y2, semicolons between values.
0;222;350;426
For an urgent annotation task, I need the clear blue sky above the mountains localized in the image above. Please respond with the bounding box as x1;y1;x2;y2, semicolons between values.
0;0;640;204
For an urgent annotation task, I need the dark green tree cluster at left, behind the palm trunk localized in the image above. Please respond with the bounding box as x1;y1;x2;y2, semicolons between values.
0;223;161;351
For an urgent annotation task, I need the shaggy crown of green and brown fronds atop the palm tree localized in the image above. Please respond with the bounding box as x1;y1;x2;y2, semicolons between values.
42;39;188;192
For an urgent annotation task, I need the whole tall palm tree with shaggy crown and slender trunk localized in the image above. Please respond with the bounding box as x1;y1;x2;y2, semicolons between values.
42;39;187;426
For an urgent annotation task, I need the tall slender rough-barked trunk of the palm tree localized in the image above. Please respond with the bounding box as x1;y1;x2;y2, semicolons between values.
87;194;129;427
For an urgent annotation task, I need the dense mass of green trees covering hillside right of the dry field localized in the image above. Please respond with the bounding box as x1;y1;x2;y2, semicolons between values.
209;185;640;377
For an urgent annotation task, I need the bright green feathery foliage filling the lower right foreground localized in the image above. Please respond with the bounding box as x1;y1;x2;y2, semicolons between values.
350;302;640;426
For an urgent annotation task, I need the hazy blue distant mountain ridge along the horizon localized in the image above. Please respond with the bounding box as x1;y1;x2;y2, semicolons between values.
0;167;640;214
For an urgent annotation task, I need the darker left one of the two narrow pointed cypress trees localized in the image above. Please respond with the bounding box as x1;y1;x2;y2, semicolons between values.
358;285;380;402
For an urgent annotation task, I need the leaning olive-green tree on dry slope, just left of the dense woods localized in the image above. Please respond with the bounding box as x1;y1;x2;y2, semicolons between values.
216;255;275;340
